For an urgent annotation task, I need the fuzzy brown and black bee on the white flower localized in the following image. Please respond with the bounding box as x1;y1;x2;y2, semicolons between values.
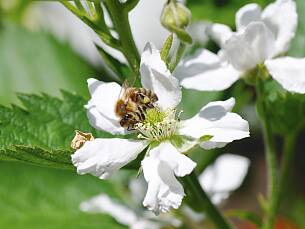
115;82;158;130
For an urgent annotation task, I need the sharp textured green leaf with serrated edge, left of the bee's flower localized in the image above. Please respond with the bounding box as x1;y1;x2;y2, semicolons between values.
0;91;111;168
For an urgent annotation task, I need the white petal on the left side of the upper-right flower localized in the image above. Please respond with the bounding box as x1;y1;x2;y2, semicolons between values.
174;49;240;91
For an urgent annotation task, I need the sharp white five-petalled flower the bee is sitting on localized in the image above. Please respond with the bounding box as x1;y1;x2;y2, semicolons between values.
72;43;249;214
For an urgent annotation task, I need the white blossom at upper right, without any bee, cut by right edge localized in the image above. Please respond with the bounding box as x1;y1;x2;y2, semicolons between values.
174;0;305;93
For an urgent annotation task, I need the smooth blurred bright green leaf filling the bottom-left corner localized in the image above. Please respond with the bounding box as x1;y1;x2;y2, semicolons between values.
0;161;126;229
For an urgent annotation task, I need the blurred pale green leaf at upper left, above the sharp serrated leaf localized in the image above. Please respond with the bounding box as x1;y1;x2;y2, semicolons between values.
0;23;97;105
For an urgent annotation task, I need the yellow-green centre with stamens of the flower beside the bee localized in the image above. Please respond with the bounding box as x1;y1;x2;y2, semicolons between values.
135;108;179;142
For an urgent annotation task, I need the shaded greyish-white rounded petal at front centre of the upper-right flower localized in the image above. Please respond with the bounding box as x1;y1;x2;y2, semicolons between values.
224;22;274;71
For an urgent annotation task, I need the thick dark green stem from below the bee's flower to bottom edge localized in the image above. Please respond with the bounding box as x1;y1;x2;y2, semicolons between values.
182;172;232;229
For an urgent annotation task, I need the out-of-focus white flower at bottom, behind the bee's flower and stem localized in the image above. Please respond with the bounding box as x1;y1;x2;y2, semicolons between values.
80;154;250;226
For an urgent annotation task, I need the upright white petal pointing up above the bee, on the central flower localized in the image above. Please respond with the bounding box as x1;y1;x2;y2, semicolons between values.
140;43;182;110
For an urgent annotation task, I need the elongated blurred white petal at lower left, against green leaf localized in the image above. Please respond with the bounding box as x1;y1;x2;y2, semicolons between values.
80;194;138;226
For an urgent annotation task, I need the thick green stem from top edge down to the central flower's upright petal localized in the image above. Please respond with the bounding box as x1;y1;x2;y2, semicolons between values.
104;0;140;76
